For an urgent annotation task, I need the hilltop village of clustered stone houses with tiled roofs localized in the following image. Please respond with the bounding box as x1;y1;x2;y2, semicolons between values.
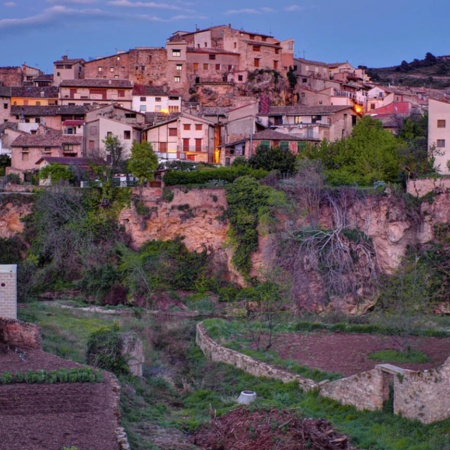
0;25;450;181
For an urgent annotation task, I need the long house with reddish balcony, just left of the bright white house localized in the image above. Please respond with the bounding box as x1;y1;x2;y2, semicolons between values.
59;78;133;108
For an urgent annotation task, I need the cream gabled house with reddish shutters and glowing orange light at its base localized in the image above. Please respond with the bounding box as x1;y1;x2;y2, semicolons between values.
143;113;218;163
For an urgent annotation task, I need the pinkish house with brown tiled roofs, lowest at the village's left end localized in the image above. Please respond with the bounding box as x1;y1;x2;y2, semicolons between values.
6;125;83;181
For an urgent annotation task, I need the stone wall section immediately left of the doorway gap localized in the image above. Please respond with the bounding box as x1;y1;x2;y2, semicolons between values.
320;368;389;411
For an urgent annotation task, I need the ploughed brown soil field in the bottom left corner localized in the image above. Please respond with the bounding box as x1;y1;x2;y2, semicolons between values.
0;347;119;450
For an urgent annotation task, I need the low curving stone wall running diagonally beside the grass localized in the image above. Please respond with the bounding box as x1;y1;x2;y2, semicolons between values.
196;323;318;391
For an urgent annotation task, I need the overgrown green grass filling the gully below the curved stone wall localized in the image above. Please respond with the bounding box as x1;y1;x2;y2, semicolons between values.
19;303;450;450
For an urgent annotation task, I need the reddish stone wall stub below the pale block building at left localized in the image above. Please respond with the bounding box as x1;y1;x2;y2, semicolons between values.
0;318;41;350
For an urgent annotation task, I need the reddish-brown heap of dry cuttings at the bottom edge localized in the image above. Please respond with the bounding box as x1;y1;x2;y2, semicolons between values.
191;407;353;450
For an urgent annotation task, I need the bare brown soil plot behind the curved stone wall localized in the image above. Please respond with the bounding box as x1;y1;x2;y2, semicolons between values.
272;331;450;376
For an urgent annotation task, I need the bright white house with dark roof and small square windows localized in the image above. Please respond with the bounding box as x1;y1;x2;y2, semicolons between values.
132;84;181;113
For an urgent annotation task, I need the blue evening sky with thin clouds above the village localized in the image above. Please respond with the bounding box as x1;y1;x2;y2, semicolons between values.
0;0;450;73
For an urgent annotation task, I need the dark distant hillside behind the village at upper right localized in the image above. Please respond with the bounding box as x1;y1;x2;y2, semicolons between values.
367;53;450;89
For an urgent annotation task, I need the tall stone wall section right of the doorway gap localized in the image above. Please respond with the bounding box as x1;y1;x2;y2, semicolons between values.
394;358;450;423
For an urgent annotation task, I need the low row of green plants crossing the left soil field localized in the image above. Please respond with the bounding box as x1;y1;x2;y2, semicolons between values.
0;367;103;384
